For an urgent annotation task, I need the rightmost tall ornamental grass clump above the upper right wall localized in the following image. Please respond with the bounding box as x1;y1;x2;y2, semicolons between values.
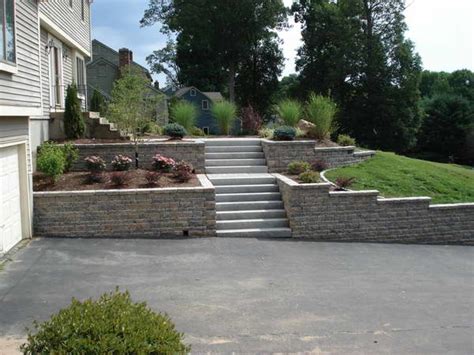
306;93;337;139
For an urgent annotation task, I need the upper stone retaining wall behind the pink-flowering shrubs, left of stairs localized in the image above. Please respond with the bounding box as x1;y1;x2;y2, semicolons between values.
67;140;205;173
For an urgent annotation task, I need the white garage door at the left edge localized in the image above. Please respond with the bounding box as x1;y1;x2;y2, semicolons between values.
0;146;22;252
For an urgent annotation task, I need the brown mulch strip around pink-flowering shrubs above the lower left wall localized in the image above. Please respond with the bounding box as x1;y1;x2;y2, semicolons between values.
33;169;200;191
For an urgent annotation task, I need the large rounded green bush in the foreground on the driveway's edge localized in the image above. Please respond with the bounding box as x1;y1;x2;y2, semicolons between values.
21;289;190;354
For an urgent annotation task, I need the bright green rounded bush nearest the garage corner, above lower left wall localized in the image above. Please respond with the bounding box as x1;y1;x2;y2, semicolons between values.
36;143;66;183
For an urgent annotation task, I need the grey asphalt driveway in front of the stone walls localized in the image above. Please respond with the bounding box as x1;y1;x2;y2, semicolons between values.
0;238;474;354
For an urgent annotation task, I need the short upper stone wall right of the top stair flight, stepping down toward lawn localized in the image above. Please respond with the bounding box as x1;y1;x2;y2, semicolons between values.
262;139;375;173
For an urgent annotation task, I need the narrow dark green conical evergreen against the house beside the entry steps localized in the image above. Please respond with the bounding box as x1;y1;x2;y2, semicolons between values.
64;84;86;139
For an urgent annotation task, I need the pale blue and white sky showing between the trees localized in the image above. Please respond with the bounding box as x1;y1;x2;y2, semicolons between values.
92;0;474;85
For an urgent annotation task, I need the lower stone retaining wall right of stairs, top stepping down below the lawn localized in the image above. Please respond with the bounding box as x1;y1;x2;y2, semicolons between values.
274;174;474;245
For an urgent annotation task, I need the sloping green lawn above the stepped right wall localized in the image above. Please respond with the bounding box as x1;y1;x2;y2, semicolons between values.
326;152;474;203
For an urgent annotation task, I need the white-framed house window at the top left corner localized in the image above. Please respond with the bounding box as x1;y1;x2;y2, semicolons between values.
0;0;16;63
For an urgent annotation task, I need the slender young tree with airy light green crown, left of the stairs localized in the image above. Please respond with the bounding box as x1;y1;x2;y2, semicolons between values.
107;68;163;168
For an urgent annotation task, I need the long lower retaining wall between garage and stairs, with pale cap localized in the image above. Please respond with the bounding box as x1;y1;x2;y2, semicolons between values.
33;175;216;238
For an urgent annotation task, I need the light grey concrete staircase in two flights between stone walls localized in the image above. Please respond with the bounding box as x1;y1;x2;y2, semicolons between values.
206;138;291;238
